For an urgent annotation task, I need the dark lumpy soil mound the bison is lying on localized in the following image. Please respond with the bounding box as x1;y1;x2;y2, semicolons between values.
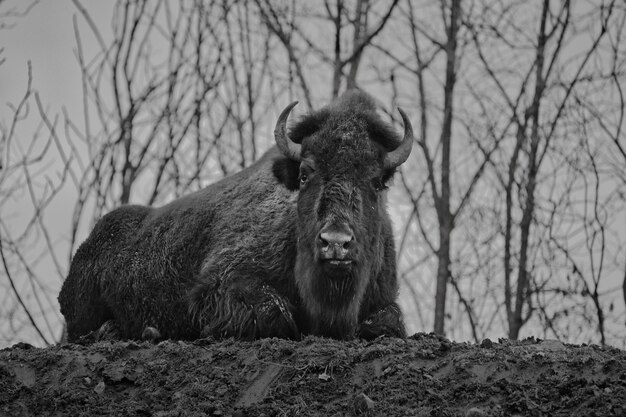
0;334;626;417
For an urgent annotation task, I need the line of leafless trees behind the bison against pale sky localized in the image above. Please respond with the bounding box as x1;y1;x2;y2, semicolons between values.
0;0;626;348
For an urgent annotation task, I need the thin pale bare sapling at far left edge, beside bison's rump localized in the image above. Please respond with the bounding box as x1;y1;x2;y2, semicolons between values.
0;63;68;345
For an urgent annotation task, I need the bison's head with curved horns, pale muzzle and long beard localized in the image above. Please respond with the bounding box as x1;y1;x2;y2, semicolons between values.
274;91;413;338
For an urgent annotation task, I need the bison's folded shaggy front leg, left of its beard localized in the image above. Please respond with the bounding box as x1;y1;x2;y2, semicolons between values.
191;280;300;340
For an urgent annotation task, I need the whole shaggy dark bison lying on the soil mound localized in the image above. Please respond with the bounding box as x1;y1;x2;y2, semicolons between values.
59;90;414;342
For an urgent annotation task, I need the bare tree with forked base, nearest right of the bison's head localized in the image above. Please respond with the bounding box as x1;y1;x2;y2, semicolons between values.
379;1;502;339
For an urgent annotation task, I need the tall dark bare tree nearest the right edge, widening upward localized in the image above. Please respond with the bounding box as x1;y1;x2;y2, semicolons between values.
468;1;623;343
